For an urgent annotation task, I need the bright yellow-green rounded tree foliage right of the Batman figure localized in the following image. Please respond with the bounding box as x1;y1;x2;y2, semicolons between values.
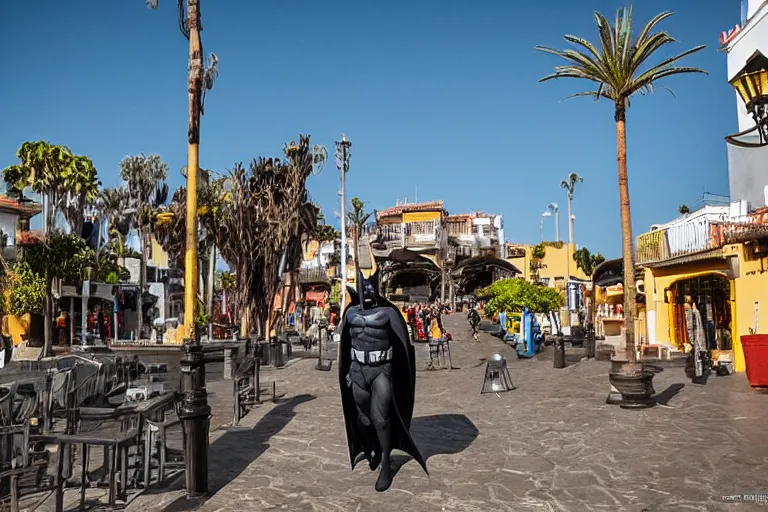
480;277;565;316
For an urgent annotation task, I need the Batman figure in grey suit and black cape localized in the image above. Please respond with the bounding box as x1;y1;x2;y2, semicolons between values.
339;247;429;492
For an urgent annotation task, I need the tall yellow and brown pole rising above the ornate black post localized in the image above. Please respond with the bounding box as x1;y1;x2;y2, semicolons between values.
184;0;203;338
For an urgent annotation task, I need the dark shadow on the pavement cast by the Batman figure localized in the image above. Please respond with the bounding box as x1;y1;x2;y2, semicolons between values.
392;414;479;475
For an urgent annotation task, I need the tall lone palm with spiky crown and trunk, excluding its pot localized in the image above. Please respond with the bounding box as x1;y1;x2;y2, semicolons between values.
536;7;705;371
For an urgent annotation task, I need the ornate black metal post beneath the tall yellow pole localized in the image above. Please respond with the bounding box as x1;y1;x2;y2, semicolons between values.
179;338;211;499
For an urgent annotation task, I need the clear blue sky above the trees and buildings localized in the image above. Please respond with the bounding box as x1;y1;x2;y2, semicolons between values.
0;0;740;257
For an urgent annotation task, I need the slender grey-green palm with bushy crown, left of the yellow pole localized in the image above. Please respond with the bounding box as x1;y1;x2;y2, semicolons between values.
120;155;169;340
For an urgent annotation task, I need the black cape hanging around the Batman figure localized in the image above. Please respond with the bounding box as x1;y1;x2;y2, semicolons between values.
339;290;429;474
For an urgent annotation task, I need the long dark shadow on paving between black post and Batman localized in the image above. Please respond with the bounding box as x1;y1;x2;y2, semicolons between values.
164;394;317;512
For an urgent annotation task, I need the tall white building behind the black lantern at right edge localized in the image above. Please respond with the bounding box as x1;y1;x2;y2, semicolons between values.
720;0;768;208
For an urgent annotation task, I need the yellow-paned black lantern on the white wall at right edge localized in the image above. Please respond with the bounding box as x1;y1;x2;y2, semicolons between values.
725;51;768;147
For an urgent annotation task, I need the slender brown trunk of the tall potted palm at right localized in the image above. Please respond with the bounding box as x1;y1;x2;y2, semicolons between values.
614;103;637;371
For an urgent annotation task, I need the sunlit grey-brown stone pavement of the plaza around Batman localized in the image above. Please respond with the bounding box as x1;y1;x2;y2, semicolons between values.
130;314;768;512
